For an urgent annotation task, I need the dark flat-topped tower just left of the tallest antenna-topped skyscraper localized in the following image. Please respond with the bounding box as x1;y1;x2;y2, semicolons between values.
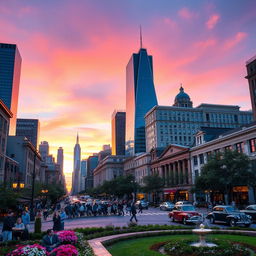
111;111;125;155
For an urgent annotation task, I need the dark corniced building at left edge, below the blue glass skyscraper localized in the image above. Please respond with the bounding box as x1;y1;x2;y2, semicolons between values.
0;99;12;184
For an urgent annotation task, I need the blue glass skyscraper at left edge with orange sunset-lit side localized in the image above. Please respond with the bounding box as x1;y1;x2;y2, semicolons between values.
0;43;21;135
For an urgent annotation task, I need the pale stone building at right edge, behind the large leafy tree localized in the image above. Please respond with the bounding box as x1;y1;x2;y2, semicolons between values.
190;122;256;205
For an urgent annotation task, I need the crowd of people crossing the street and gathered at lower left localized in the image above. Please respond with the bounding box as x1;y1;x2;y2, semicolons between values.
0;200;143;241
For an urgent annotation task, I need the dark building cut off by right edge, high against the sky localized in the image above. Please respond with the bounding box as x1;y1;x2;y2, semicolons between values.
245;55;256;121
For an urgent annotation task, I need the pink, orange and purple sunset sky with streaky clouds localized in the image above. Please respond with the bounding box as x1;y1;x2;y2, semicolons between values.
0;0;256;192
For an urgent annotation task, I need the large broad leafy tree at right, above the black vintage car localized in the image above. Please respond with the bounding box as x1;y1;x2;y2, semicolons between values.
195;150;256;203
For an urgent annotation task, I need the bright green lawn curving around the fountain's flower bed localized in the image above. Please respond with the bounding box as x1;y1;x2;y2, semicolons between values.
107;234;256;256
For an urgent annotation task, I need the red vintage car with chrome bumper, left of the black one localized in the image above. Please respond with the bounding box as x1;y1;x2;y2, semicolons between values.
169;204;203;224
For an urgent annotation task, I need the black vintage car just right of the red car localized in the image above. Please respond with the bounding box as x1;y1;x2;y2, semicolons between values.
206;205;252;227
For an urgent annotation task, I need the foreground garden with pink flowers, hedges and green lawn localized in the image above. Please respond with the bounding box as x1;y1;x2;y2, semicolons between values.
0;224;256;256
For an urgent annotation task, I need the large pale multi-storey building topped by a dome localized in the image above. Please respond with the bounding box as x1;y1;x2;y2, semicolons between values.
145;87;253;152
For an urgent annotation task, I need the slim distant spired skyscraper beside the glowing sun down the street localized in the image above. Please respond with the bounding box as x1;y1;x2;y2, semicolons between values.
72;134;81;195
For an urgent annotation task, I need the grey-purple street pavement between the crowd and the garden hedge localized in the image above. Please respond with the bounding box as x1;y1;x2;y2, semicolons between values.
0;208;256;232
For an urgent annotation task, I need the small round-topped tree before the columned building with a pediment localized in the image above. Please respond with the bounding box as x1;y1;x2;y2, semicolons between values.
142;174;164;203
